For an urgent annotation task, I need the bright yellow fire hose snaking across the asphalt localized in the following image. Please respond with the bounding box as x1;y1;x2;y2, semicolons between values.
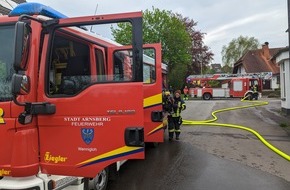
182;98;290;161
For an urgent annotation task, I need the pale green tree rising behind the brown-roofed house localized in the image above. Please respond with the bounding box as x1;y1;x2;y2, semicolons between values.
221;36;260;67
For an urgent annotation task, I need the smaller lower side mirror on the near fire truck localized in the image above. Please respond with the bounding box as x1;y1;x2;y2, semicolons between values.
12;74;30;95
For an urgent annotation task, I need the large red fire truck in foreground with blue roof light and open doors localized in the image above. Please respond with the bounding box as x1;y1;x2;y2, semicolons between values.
0;3;164;190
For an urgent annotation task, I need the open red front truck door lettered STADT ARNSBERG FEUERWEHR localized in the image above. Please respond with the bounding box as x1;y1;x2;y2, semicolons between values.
37;14;144;177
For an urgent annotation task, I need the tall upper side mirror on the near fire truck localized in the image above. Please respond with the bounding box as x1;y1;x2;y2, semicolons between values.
13;22;31;71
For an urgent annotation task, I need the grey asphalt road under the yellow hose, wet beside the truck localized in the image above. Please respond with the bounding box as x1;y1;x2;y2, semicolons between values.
108;99;290;190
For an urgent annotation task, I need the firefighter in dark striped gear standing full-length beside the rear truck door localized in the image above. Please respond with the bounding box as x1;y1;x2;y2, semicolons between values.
168;90;186;141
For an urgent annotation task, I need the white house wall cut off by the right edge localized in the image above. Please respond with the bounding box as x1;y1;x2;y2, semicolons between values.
272;47;290;115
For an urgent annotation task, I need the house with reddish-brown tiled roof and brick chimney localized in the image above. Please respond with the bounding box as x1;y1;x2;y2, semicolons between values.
233;42;282;90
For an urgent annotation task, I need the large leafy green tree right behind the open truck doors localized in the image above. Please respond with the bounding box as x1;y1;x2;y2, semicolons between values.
111;7;203;89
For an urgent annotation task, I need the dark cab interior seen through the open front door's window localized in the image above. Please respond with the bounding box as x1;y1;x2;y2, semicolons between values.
48;32;91;95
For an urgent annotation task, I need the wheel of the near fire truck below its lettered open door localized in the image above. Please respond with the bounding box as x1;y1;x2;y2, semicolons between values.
89;168;109;190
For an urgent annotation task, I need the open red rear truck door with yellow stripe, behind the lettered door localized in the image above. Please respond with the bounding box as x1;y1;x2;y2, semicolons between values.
143;44;164;142
